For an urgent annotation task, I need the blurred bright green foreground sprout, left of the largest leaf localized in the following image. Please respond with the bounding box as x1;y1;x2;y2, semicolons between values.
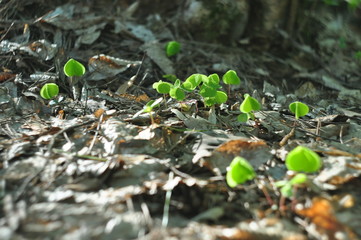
226;157;256;188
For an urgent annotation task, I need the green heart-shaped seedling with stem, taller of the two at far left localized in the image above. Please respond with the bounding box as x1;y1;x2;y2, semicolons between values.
63;58;86;99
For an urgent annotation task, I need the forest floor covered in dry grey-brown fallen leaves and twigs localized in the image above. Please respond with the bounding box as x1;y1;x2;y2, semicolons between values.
0;1;361;240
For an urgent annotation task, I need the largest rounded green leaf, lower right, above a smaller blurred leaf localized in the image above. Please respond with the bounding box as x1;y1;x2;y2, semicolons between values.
286;146;322;172
